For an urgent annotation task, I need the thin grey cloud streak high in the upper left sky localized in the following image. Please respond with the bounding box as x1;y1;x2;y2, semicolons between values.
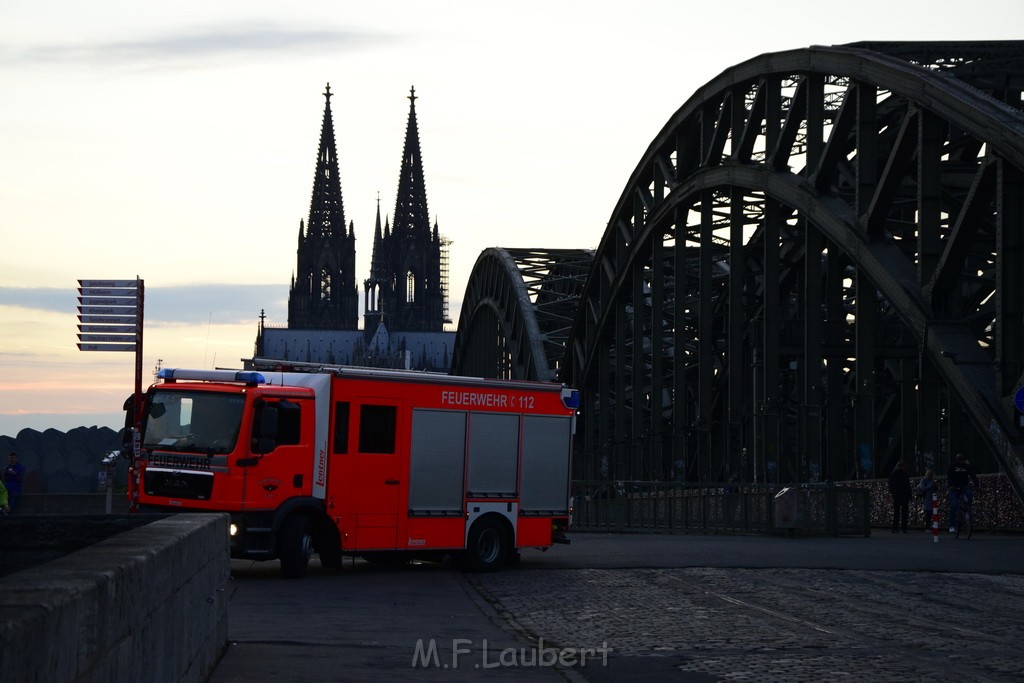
3;23;397;68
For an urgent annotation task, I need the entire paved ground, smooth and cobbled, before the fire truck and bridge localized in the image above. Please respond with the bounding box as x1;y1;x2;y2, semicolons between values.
211;531;1024;683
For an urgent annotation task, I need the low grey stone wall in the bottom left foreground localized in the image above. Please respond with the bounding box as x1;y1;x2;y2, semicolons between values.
0;514;230;683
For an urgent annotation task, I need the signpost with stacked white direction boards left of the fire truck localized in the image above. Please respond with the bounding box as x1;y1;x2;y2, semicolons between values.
78;278;145;510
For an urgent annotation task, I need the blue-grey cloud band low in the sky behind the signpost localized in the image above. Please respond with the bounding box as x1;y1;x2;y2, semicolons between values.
0;285;288;325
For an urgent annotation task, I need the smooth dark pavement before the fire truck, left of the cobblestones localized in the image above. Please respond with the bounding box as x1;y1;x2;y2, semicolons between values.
209;560;577;683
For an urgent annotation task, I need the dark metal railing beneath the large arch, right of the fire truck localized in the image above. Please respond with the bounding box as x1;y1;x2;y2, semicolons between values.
572;481;870;537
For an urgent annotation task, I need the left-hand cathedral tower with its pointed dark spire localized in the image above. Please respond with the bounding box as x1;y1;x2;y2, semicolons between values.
288;83;358;330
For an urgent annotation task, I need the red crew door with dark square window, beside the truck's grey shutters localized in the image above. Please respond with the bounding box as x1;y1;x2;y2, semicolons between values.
351;398;408;550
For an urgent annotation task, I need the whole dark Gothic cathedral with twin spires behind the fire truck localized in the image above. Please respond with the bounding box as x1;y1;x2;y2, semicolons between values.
255;84;455;372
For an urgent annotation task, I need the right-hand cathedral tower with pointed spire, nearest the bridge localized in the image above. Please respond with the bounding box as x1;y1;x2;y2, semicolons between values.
364;88;445;335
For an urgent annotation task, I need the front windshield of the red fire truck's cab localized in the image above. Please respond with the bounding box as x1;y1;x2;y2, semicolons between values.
142;389;245;454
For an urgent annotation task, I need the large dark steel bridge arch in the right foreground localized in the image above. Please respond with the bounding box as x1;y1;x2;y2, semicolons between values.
456;42;1024;496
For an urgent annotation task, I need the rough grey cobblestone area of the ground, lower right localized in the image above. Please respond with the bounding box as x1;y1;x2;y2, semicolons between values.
470;568;1024;681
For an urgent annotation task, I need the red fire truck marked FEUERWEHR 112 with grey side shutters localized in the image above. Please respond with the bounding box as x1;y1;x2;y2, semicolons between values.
130;364;579;578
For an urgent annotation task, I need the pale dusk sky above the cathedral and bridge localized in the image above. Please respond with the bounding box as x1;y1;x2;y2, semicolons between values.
0;0;1024;436
